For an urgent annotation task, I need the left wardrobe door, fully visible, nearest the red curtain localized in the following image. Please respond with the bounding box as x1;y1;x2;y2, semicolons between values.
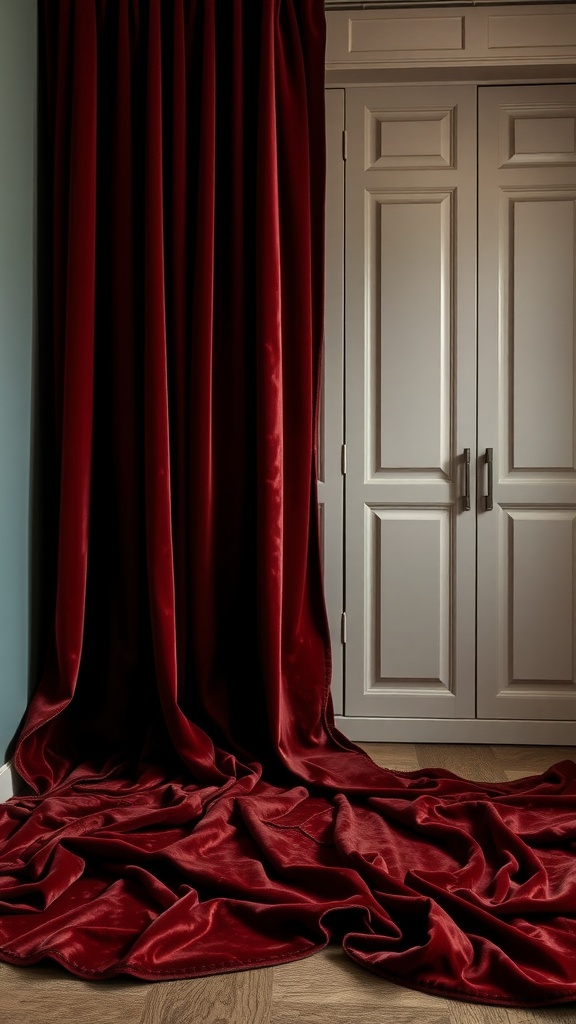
344;85;477;720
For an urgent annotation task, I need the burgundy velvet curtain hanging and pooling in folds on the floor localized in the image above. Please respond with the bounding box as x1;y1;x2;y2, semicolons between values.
0;0;576;1006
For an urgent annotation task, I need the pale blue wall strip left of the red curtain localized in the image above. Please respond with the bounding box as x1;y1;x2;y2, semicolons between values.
0;0;36;764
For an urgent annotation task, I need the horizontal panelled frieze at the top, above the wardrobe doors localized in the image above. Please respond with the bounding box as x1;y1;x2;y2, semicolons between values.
326;3;576;71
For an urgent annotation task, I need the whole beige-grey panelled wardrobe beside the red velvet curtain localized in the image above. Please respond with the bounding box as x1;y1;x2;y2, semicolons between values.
319;5;576;743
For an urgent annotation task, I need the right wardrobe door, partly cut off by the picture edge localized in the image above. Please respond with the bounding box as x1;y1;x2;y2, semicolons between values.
478;85;576;724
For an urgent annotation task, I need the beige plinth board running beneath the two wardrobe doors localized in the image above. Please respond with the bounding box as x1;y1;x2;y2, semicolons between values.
335;715;576;746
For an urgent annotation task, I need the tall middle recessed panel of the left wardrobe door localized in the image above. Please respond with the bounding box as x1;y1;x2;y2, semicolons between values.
369;193;454;479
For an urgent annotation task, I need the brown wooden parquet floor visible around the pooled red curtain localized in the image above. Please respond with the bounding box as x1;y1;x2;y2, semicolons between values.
0;743;576;1024
